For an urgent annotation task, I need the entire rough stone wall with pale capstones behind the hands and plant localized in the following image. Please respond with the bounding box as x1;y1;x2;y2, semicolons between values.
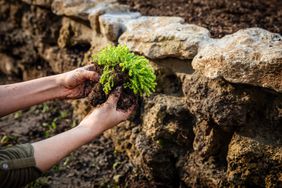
0;0;282;187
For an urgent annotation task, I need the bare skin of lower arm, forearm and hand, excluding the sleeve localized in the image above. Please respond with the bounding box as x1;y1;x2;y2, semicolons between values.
32;87;134;172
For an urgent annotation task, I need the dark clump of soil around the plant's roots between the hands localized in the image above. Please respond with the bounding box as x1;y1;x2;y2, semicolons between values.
89;62;137;111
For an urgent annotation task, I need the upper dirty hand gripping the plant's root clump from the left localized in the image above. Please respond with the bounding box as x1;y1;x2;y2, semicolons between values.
58;65;99;99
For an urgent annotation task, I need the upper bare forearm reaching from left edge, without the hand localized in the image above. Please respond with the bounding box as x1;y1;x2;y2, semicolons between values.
0;75;66;117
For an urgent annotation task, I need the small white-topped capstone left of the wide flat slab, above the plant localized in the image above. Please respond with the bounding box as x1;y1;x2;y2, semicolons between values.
99;12;141;41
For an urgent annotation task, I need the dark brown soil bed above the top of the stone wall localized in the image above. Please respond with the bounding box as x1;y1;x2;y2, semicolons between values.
119;0;282;37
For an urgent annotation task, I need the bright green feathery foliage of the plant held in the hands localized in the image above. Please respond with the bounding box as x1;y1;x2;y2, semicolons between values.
93;45;156;96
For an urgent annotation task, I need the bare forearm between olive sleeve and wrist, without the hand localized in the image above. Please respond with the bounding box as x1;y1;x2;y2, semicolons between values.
32;125;103;172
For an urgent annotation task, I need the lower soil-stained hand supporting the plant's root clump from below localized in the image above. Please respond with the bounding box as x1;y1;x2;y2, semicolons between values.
79;88;135;137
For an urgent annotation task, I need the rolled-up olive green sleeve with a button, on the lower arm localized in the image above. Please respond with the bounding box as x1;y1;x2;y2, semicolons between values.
0;144;41;187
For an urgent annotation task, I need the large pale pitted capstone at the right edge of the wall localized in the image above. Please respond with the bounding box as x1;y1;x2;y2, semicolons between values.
192;28;282;92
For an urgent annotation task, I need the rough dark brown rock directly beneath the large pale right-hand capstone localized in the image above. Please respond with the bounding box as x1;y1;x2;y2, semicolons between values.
183;73;259;131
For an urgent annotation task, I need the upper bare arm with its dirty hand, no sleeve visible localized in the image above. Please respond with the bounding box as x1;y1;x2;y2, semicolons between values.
0;65;99;117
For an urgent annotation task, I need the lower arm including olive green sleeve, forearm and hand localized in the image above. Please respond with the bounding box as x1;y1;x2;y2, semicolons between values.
0;88;134;187
